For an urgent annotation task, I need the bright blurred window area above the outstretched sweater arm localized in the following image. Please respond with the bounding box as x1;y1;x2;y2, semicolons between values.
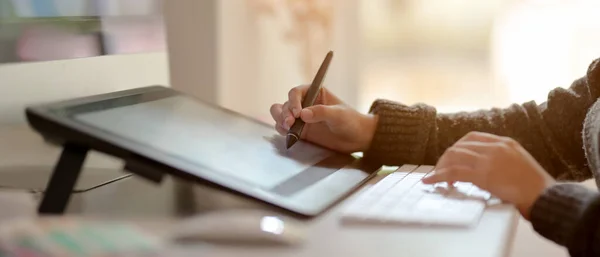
361;0;600;112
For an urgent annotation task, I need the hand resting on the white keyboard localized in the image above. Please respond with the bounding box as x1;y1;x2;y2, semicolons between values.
423;132;555;219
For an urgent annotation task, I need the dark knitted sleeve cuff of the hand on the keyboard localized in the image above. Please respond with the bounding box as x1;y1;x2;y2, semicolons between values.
531;184;600;256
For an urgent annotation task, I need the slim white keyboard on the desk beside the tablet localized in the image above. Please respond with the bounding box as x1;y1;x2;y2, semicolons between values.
341;165;494;227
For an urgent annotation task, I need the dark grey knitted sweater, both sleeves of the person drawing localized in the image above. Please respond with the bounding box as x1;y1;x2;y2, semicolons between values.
364;59;600;256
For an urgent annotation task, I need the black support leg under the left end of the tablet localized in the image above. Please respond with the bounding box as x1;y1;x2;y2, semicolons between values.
38;143;89;214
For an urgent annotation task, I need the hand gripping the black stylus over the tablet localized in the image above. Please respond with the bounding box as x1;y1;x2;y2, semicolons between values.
271;86;377;153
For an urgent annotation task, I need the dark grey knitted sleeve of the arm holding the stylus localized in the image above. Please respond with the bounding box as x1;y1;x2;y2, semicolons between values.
364;59;600;180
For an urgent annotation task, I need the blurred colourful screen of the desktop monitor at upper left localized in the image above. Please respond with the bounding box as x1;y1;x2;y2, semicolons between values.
0;0;165;63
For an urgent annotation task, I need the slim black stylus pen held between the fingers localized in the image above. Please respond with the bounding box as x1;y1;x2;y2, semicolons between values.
285;51;333;149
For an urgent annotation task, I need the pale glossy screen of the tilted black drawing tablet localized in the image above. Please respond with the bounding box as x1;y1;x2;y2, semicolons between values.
74;95;335;188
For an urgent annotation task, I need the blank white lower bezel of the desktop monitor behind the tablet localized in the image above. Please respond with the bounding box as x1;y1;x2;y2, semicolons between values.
0;53;169;124
